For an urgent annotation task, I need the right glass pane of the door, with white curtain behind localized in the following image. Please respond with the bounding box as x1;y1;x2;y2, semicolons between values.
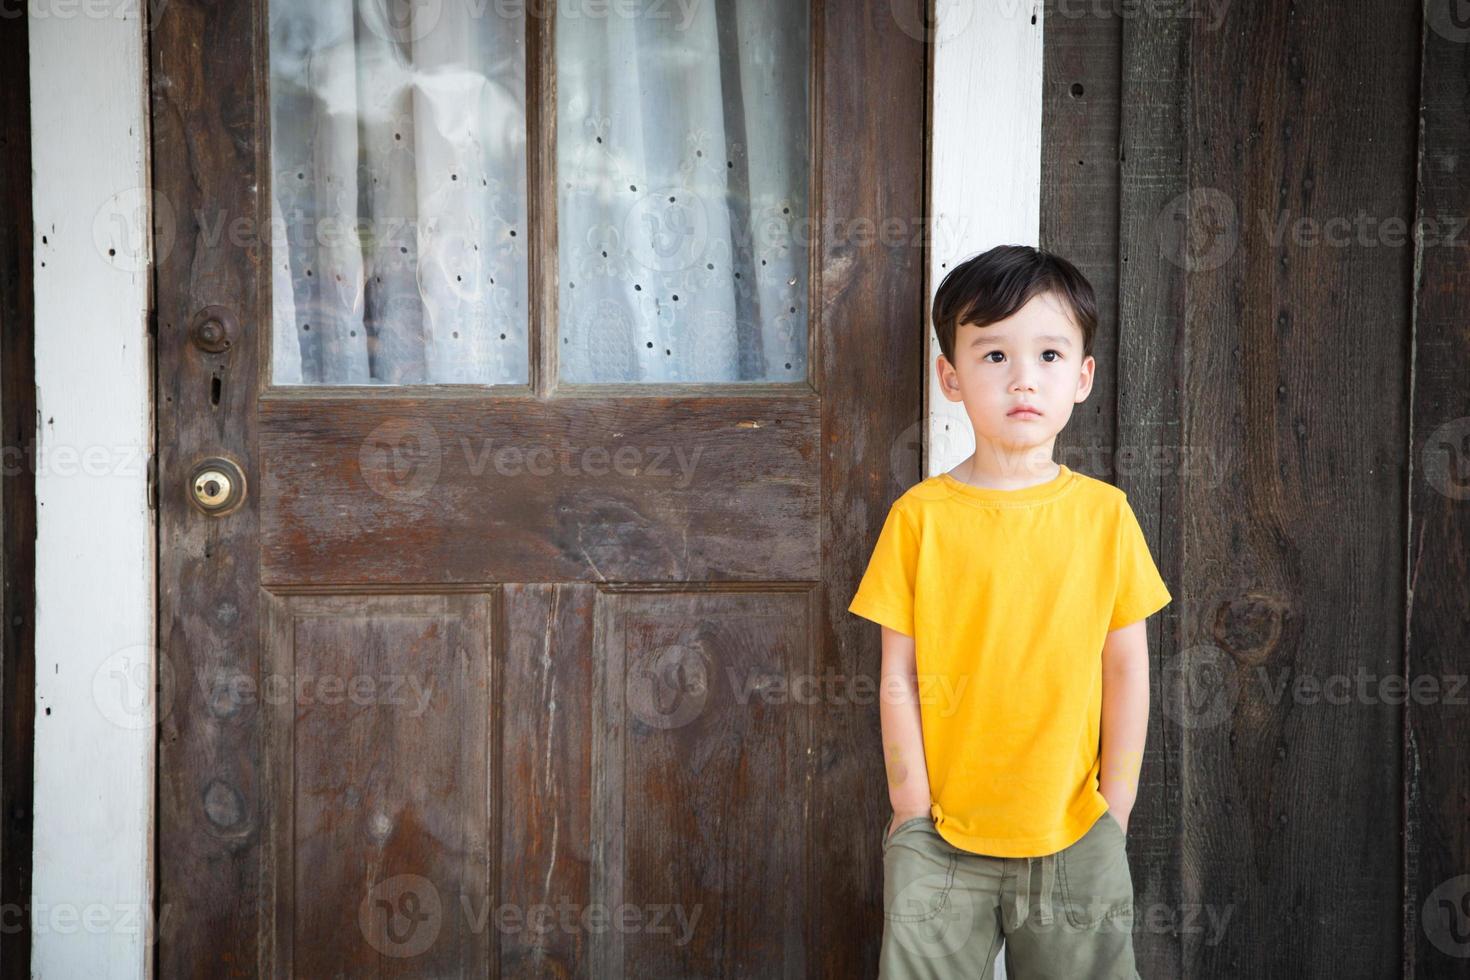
556;0;813;382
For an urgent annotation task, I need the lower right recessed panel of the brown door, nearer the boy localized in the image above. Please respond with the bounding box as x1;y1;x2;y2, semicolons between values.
589;586;814;980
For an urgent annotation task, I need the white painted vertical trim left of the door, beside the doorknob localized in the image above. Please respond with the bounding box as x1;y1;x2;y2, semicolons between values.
29;0;156;980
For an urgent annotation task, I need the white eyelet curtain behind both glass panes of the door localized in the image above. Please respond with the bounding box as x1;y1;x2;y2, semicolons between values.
269;0;811;385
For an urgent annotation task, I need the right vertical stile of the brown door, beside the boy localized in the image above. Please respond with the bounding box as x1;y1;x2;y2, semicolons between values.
806;0;931;980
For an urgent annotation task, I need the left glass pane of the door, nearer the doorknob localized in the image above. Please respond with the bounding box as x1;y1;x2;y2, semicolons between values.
269;0;529;385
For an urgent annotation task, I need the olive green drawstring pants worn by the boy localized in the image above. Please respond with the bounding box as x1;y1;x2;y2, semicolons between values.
878;813;1138;980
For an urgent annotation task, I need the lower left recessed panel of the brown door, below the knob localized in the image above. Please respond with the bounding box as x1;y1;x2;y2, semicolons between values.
263;594;500;977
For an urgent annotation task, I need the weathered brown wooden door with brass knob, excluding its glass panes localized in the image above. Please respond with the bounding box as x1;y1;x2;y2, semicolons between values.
151;0;926;977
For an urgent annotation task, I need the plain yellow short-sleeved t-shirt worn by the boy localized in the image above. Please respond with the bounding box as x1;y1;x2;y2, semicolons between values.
847;466;1172;857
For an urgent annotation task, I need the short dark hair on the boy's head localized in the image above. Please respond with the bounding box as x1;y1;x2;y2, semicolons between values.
932;245;1098;364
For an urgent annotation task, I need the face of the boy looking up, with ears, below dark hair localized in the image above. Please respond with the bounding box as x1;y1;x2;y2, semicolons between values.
936;292;1095;458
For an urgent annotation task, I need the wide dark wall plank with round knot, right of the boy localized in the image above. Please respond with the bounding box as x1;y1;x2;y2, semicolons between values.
1181;3;1420;980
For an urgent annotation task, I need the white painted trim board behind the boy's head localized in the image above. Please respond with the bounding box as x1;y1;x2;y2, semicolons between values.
925;0;1042;476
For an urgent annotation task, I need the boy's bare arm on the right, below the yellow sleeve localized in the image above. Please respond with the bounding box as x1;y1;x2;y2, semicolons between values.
1098;620;1148;832
